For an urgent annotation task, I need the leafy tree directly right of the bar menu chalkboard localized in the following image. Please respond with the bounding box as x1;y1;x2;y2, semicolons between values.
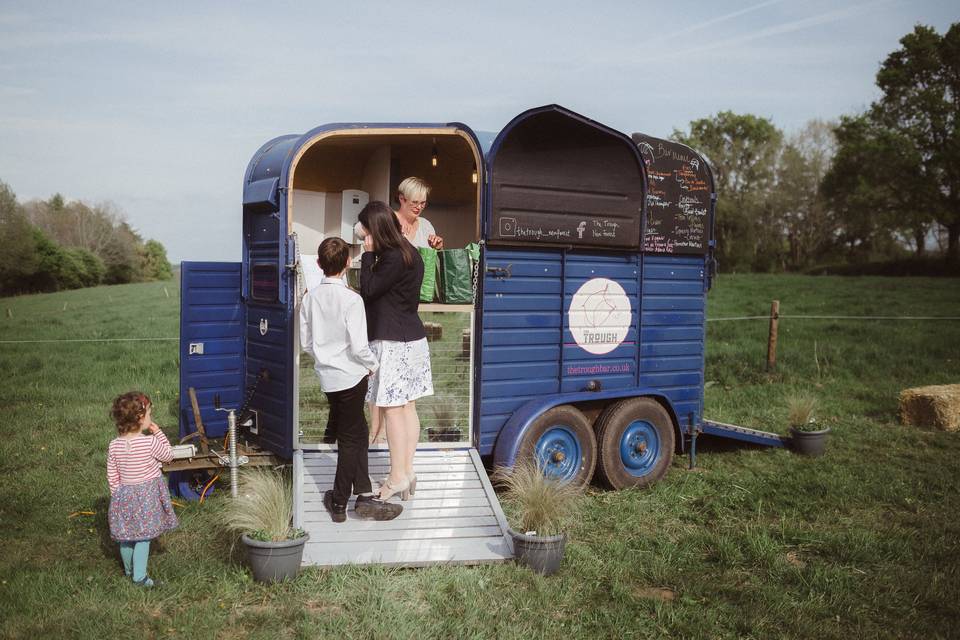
673;111;783;271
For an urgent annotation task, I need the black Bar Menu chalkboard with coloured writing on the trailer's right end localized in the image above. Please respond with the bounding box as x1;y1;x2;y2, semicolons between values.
633;133;713;254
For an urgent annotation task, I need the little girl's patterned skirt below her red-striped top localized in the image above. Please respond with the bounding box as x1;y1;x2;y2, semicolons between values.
108;476;179;542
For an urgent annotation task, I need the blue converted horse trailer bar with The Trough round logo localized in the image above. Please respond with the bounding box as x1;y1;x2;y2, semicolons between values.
180;105;788;488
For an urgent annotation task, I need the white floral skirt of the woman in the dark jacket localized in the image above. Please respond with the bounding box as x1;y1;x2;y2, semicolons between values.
367;338;433;407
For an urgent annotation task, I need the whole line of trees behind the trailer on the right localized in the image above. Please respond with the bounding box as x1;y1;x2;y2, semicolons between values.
673;23;960;272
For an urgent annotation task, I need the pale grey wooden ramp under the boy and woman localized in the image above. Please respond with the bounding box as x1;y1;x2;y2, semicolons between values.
294;449;513;567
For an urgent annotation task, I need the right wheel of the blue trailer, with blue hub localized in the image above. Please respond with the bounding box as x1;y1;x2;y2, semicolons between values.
597;398;674;489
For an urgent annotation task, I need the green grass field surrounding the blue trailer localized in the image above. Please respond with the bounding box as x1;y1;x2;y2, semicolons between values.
0;275;960;639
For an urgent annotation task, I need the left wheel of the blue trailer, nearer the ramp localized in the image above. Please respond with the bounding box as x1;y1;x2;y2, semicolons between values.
517;405;597;486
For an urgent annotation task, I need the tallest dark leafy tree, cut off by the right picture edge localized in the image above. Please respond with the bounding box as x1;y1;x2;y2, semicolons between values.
871;23;960;262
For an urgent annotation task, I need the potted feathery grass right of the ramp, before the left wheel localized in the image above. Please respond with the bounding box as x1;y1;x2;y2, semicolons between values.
494;462;583;575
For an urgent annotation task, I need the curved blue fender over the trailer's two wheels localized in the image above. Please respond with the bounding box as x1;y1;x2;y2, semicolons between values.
493;387;683;467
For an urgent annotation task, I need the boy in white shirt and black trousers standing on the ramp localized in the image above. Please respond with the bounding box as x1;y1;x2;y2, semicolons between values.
300;238;403;522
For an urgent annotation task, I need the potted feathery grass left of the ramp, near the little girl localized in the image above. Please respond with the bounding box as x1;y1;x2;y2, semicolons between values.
222;467;310;582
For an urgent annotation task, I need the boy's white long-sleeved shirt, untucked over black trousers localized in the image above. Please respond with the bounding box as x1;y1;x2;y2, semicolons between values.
300;276;380;393
